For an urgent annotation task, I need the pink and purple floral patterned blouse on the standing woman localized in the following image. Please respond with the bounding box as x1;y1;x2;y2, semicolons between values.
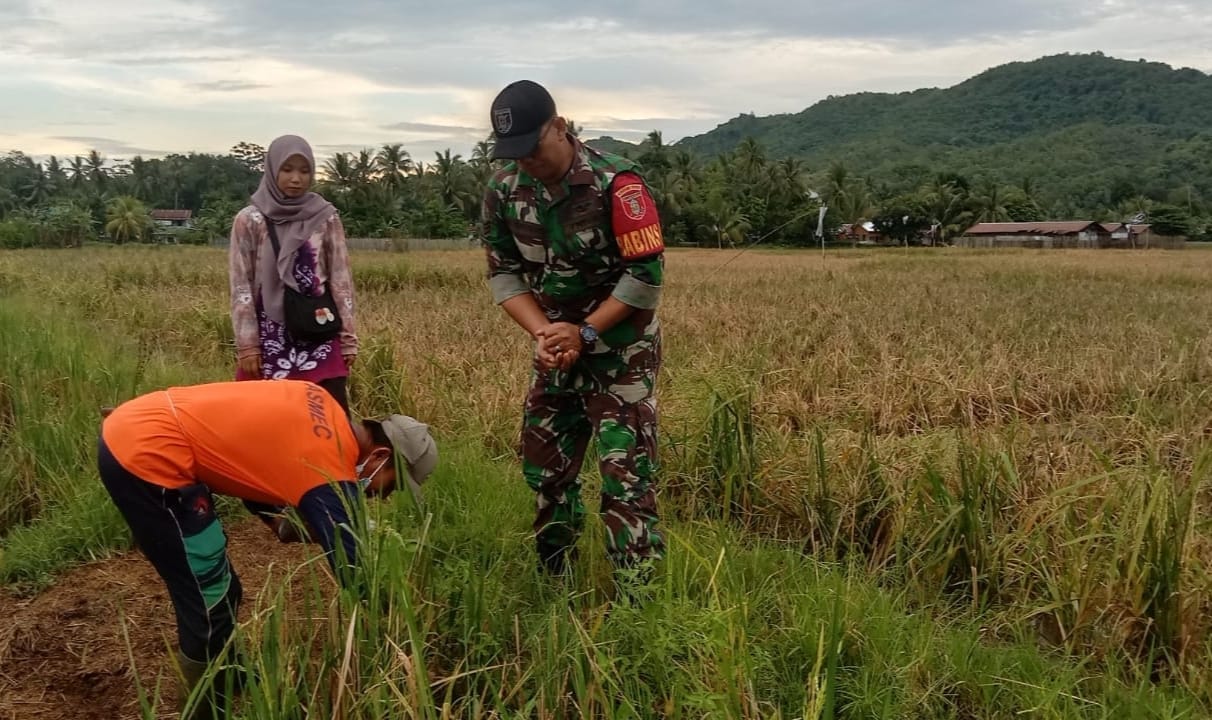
228;205;358;382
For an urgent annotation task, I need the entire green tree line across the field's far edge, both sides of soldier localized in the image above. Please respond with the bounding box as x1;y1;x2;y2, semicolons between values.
0;124;1210;247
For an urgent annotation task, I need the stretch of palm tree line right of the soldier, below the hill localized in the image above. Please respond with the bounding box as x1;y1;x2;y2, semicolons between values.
590;131;1208;247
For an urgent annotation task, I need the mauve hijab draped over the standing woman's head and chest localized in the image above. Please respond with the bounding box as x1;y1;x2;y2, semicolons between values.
252;135;337;322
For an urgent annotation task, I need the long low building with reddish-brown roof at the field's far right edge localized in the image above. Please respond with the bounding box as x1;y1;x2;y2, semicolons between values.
955;221;1185;248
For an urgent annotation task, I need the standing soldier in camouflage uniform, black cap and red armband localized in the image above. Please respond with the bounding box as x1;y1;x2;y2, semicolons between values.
482;81;664;575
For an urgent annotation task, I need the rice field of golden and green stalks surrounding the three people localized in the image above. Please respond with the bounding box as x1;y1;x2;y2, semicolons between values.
0;246;1212;719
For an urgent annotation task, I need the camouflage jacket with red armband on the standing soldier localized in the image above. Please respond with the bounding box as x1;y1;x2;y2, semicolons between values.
482;138;664;348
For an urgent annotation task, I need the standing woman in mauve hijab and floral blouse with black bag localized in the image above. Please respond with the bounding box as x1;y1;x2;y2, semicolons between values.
228;135;358;413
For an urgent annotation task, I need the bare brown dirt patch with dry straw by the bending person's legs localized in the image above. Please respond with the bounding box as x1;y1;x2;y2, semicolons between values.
0;518;309;720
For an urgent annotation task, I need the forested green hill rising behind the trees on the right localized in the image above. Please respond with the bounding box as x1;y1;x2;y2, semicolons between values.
675;53;1212;207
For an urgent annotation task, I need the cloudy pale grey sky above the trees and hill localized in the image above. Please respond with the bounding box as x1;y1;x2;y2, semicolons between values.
0;0;1212;160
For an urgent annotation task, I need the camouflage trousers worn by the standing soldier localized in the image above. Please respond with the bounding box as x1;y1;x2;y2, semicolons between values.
522;336;664;566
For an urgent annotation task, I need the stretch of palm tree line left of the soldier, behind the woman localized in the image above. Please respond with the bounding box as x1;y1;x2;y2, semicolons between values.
0;142;492;247
